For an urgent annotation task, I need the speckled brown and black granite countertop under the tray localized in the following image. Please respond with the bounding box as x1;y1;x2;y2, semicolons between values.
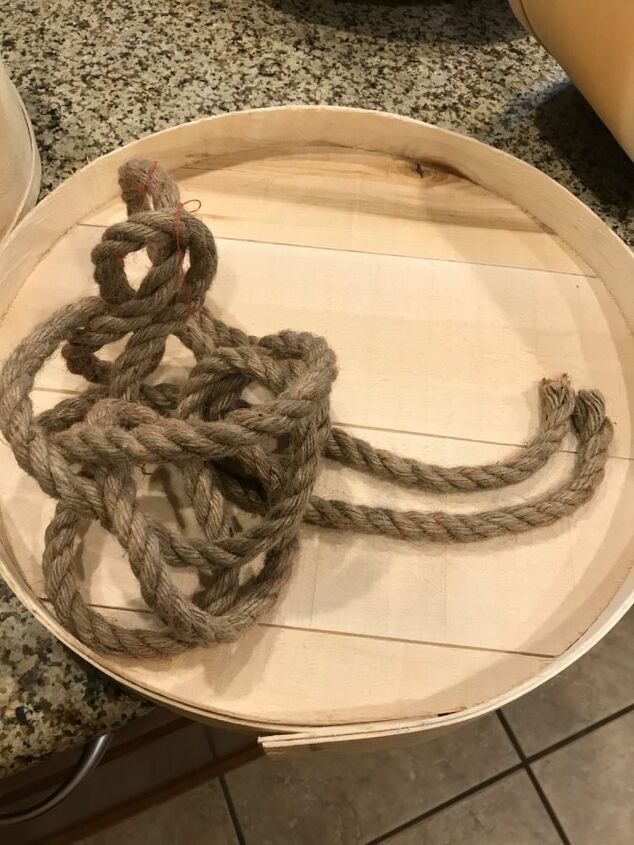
0;0;634;776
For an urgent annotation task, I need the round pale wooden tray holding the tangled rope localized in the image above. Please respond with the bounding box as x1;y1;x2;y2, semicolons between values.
0;107;634;753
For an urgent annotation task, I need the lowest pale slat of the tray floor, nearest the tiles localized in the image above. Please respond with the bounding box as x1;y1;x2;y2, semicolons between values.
71;611;548;725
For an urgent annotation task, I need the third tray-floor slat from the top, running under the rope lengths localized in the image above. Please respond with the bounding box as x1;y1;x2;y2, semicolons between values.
0;392;634;655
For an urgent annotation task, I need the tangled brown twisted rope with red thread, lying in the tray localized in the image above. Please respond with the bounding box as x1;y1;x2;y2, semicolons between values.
0;160;612;657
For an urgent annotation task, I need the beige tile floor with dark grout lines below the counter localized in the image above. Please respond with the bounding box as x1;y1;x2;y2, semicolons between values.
66;612;634;845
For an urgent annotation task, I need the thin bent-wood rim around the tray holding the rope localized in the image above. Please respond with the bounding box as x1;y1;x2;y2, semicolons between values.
0;106;634;754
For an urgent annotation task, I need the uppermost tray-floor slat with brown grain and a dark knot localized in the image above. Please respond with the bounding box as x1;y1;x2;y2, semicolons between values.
84;145;590;273
